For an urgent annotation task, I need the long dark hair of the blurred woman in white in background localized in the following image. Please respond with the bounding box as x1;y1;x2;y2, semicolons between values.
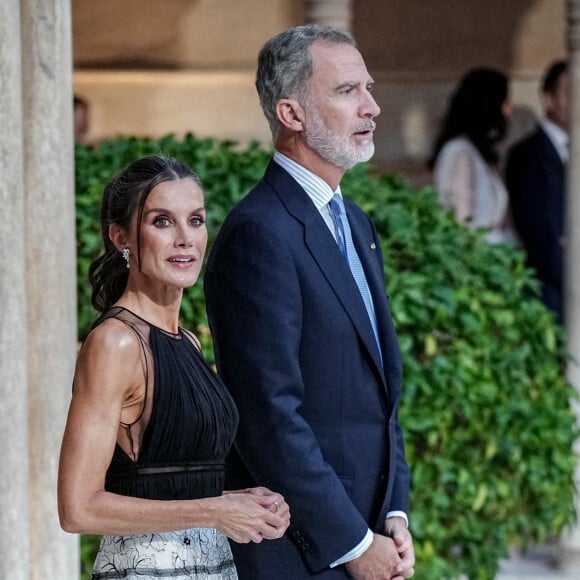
429;68;508;167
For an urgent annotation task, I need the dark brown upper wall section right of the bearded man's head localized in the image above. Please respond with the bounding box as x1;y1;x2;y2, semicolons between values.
353;0;565;79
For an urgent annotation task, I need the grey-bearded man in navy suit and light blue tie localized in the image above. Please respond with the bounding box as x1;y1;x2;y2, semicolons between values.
205;25;415;580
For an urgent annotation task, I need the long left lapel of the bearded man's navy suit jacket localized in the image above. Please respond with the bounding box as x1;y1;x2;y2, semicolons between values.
265;162;384;382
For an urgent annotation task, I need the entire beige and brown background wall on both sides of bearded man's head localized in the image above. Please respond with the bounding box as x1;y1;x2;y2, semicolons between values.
73;0;566;180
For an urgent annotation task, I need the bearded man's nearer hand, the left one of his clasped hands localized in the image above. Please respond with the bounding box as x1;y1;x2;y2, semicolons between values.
345;534;404;580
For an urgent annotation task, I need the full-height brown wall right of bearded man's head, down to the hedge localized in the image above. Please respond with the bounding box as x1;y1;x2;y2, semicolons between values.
353;0;566;181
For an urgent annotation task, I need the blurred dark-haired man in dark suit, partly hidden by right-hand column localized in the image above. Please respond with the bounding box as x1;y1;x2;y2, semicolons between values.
506;61;568;322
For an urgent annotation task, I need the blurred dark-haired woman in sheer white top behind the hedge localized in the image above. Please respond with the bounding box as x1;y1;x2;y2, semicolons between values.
429;68;516;243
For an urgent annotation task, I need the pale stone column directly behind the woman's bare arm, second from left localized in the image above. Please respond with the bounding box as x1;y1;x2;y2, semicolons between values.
20;0;79;580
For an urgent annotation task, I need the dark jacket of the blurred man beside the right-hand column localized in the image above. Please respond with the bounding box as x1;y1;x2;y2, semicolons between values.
506;127;566;320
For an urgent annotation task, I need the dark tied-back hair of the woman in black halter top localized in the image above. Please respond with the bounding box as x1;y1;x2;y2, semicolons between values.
89;155;201;313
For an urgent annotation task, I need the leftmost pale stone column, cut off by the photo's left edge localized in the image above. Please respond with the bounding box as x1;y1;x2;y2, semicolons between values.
0;0;30;580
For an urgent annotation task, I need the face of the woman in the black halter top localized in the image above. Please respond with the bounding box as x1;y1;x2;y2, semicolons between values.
128;178;207;288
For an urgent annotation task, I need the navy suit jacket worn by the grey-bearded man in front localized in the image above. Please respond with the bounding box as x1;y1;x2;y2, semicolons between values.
205;161;409;580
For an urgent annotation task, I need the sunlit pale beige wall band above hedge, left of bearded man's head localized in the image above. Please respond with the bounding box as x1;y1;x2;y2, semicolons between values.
74;71;270;143
